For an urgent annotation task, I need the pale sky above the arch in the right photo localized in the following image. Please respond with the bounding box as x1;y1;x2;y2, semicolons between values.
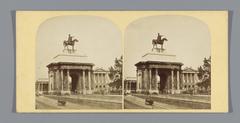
124;15;211;77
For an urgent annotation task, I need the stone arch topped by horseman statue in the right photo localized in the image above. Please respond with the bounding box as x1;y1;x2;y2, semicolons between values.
135;33;183;94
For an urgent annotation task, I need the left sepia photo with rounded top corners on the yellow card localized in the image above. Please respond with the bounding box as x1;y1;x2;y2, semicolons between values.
17;12;122;111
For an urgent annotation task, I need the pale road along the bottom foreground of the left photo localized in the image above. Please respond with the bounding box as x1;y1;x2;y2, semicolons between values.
36;96;110;109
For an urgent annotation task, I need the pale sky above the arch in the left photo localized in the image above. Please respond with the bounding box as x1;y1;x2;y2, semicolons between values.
36;16;122;79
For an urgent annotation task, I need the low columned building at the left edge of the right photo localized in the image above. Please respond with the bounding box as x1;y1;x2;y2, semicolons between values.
124;77;137;93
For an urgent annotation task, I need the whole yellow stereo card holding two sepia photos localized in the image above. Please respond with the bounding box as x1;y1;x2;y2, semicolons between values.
16;11;228;112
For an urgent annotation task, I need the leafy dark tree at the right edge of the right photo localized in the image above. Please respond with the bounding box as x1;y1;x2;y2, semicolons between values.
197;56;211;89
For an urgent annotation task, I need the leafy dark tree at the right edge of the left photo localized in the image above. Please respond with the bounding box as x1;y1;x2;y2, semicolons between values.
109;56;123;89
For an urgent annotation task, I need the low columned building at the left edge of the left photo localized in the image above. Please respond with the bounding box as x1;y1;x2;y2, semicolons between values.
35;78;49;94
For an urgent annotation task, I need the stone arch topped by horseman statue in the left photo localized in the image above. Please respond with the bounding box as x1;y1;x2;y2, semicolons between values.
47;35;94;95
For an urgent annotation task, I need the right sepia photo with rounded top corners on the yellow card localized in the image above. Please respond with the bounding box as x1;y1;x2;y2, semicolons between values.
124;15;211;110
